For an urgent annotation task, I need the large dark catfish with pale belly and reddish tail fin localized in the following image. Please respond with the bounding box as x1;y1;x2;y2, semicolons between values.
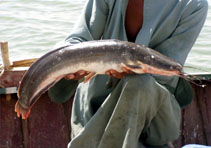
15;40;183;119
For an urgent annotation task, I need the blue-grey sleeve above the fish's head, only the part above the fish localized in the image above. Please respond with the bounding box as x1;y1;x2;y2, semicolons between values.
154;0;208;65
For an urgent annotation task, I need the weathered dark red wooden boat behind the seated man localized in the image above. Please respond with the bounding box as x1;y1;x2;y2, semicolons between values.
0;41;211;148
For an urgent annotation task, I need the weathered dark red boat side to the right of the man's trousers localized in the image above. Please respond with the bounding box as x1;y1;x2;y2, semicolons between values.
174;81;211;148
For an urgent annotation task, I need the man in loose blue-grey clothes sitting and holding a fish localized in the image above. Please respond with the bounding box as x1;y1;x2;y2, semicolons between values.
49;0;208;148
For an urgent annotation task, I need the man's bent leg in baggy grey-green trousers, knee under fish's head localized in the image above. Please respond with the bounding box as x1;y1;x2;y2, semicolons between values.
69;75;180;148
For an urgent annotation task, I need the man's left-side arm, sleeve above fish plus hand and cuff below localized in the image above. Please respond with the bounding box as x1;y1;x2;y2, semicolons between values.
48;0;108;103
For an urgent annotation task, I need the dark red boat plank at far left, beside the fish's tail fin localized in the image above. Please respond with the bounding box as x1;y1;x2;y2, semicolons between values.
0;95;24;148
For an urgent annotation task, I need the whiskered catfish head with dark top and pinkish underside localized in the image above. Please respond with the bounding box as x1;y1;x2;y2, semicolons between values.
126;47;183;76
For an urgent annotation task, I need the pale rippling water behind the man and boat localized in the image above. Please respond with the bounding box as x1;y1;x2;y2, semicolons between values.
0;0;211;73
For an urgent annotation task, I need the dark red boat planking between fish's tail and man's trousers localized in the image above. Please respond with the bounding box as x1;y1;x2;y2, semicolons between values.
23;94;70;148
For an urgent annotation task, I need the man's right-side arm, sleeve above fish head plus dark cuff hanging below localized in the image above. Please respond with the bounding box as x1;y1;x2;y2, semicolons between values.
154;0;208;107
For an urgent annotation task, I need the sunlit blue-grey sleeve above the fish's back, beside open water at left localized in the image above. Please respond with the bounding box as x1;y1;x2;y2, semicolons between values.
66;0;108;44
